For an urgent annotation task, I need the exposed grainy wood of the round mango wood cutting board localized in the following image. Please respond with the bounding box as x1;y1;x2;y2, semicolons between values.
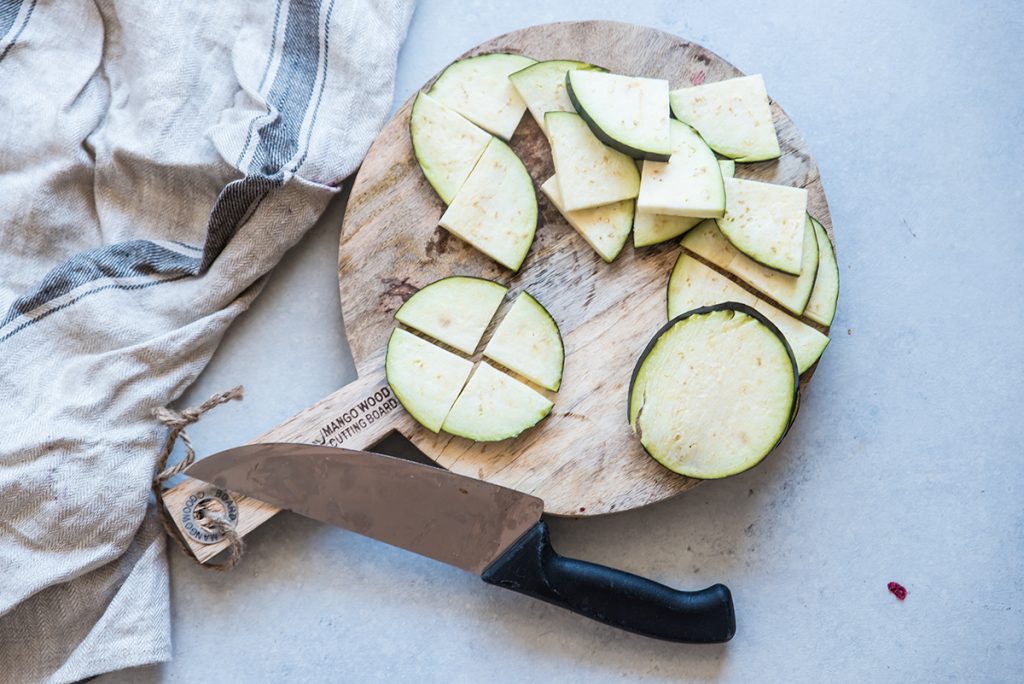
161;22;835;557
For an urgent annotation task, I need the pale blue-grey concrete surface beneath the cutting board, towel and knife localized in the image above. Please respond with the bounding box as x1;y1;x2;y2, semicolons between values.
99;0;1024;684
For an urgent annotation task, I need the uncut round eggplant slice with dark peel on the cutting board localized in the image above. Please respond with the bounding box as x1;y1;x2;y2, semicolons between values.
629;302;800;479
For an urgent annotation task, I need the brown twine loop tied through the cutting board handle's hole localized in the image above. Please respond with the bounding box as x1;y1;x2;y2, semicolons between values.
153;385;243;570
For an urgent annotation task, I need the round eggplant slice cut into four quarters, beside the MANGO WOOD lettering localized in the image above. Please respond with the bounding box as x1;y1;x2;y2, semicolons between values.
385;275;565;441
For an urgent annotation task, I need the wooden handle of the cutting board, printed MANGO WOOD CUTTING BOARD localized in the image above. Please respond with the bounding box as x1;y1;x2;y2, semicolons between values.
164;353;412;563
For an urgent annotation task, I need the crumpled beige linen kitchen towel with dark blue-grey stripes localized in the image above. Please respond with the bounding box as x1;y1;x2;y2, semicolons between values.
0;0;413;682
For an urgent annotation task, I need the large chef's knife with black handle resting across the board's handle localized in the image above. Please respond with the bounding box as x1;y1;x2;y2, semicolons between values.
186;443;736;643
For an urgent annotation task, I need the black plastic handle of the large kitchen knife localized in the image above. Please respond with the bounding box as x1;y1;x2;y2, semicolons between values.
481;521;736;644
